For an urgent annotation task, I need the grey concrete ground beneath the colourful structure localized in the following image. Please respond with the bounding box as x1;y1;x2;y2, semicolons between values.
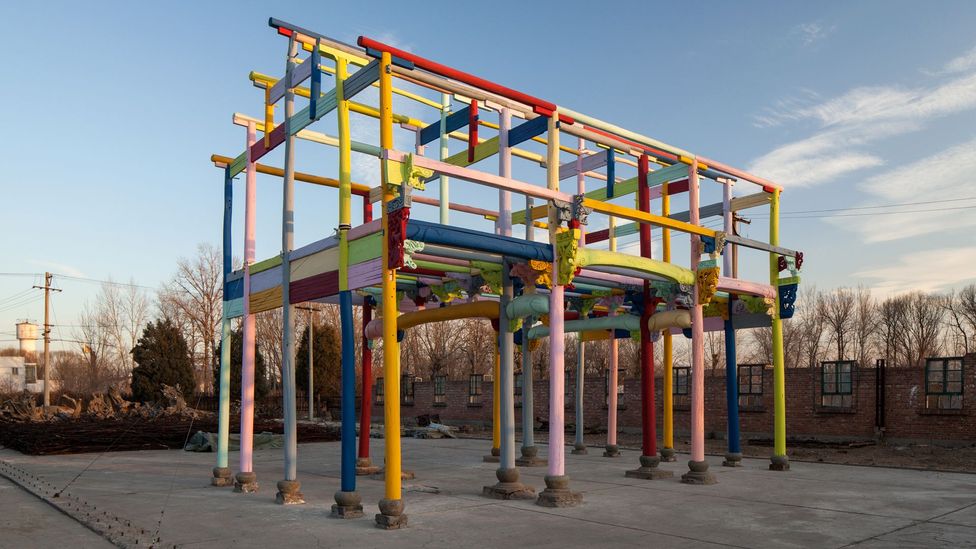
0;439;976;549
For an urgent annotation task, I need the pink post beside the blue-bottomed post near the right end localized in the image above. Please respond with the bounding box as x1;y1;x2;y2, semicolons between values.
681;158;716;484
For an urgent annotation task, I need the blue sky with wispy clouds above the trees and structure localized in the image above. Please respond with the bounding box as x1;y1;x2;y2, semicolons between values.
0;0;976;347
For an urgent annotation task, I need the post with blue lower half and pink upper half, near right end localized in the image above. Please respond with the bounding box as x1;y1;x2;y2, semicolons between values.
718;179;742;467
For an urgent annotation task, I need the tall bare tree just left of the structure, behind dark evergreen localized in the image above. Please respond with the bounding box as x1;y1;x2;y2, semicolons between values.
159;244;224;390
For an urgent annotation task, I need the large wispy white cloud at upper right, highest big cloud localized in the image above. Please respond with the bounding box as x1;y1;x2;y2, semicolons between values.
750;56;976;187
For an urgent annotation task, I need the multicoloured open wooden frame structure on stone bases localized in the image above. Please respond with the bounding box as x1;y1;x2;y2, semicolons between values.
206;19;802;528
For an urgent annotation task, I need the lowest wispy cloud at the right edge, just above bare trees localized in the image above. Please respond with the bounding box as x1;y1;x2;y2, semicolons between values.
854;247;976;297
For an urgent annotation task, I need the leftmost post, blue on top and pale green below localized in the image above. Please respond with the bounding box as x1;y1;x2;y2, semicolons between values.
210;168;234;486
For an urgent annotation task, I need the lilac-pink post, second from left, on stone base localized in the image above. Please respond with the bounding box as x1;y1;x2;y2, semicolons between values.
234;122;258;493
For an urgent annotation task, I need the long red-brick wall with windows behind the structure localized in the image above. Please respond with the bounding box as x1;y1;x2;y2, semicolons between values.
373;353;976;443
